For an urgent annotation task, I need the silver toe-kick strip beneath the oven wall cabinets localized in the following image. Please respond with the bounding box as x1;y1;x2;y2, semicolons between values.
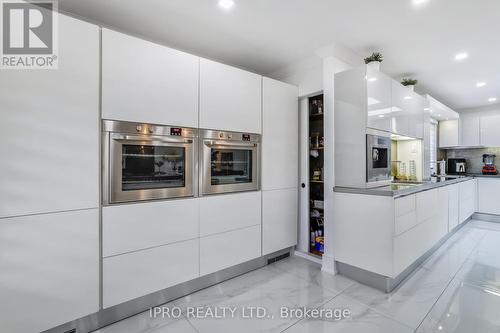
43;248;293;333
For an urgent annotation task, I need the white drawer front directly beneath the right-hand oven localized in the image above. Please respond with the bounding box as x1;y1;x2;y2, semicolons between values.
200;191;262;237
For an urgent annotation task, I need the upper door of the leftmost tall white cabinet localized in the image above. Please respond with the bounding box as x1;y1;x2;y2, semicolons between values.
0;15;100;218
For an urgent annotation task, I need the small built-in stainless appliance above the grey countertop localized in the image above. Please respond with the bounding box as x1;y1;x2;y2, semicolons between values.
366;134;391;183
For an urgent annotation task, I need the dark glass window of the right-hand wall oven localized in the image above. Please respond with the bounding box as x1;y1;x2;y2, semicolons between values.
211;148;252;185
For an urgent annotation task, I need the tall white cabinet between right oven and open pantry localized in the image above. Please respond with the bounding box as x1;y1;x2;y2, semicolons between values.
262;78;299;254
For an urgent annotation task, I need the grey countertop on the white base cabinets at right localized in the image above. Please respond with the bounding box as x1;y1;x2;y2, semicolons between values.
333;176;474;198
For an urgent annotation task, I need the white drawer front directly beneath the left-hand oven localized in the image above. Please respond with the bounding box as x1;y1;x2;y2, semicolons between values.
102;199;199;257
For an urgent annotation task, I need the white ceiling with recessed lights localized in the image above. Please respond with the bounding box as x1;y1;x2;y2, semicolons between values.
59;0;500;108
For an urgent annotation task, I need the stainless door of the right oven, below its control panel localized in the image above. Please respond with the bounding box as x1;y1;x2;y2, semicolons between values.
201;140;260;194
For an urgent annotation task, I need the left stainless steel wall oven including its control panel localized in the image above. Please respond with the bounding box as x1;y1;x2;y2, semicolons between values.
102;120;198;204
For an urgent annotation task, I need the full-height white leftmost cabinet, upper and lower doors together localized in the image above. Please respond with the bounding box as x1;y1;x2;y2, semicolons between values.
0;15;100;332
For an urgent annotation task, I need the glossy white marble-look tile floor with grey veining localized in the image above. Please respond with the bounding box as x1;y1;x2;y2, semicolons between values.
93;220;500;333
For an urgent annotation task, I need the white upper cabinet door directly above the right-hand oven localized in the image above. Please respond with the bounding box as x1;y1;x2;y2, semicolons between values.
200;58;262;133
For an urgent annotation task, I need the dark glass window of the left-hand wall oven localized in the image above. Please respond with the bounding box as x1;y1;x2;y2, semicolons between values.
122;145;186;191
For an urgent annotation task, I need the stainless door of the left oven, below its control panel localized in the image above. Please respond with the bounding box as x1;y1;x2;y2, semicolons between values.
109;133;197;203
